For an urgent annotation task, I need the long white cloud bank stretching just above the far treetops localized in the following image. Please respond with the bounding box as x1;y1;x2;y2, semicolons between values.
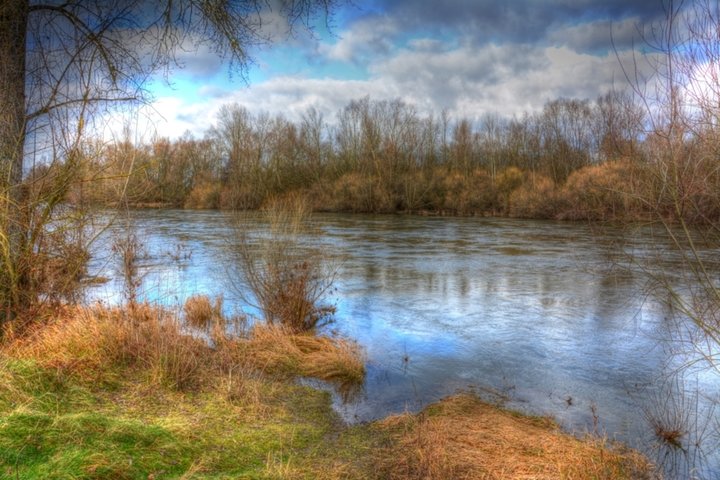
138;45;656;137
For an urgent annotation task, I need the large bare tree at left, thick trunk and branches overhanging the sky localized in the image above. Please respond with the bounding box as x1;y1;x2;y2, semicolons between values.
0;0;336;323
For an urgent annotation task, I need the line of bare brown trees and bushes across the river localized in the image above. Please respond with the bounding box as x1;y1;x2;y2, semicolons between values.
53;91;720;223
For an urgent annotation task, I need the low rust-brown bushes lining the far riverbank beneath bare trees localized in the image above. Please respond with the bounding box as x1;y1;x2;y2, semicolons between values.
105;161;660;223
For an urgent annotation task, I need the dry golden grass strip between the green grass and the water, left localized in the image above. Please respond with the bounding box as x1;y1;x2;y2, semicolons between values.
5;298;365;397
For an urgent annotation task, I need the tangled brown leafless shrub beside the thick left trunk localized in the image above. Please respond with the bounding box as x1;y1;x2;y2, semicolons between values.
0;145;92;330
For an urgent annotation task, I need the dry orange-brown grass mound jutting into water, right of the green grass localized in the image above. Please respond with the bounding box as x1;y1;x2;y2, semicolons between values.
380;395;653;480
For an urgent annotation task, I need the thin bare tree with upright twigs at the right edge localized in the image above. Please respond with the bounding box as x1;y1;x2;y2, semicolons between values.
628;0;720;364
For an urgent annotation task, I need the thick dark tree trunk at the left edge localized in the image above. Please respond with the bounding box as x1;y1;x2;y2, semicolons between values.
0;0;29;323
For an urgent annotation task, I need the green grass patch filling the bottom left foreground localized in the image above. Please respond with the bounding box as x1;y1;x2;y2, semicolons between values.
0;360;382;480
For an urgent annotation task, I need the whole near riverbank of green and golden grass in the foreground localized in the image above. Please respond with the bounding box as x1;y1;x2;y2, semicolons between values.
0;305;649;480
